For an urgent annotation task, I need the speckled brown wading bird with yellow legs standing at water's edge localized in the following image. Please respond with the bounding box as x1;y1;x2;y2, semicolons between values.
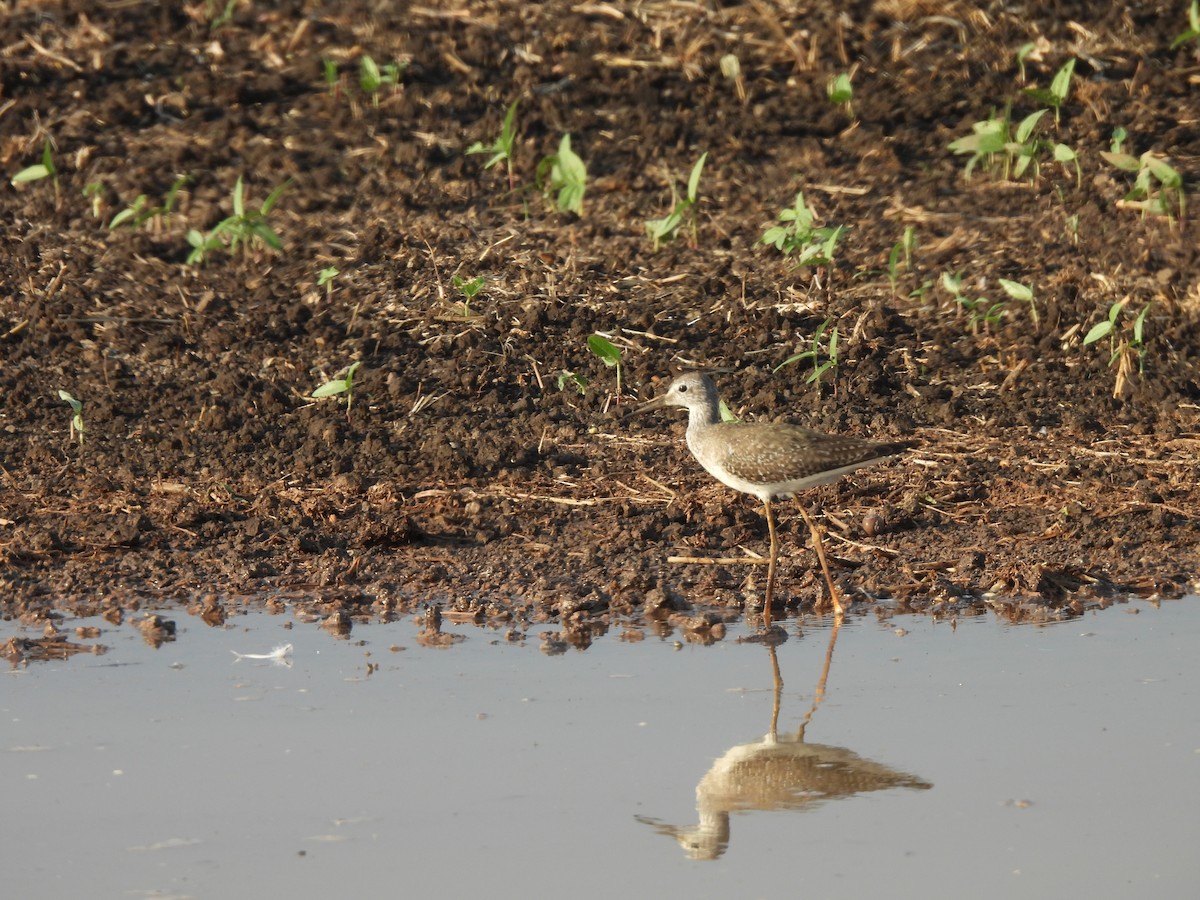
630;371;911;629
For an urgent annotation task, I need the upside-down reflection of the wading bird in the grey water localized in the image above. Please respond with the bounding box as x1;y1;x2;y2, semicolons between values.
637;618;932;859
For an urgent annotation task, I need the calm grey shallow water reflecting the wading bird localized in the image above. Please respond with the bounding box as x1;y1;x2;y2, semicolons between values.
0;598;1200;898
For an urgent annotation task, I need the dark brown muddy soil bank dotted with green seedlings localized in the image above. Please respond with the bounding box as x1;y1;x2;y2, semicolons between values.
0;0;1200;646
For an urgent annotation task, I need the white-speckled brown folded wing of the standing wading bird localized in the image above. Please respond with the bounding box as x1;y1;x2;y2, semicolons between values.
710;422;906;493
